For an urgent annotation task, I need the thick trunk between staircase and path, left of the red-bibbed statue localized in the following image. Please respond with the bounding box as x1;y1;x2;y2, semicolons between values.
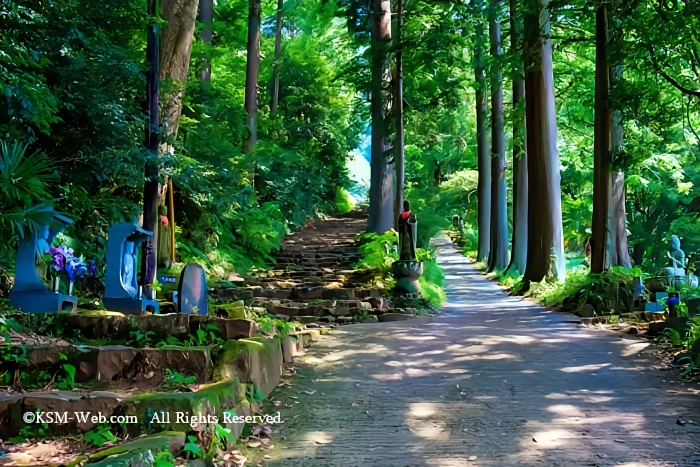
367;0;394;234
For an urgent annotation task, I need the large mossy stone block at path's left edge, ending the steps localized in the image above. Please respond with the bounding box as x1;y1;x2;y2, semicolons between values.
214;337;282;397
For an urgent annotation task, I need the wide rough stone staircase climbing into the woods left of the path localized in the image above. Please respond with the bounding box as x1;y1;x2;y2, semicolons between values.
213;212;416;324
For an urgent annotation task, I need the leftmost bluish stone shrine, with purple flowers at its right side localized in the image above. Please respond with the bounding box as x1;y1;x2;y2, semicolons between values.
9;207;78;313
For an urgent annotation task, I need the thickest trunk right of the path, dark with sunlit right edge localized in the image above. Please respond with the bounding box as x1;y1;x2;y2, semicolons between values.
523;0;566;288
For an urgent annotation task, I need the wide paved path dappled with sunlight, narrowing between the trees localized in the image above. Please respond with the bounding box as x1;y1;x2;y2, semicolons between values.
265;239;700;467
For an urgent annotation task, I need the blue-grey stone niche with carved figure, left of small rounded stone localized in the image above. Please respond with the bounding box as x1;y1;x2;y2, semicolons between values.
102;222;160;314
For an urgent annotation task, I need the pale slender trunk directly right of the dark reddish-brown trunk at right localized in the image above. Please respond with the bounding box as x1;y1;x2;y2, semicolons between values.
607;1;632;268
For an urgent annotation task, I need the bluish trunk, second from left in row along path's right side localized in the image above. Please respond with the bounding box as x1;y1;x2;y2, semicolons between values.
489;0;509;271
